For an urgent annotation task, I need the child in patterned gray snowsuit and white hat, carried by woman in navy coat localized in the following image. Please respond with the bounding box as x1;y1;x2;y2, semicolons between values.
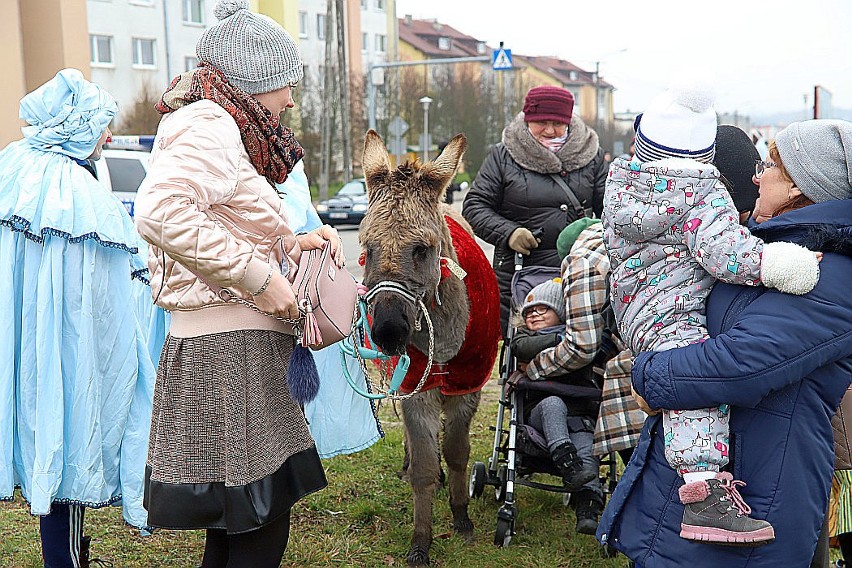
602;86;819;546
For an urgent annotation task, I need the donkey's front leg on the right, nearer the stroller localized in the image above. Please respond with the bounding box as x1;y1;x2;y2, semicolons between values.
443;391;480;541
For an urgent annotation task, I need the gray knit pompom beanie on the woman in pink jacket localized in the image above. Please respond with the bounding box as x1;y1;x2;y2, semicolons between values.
195;0;304;95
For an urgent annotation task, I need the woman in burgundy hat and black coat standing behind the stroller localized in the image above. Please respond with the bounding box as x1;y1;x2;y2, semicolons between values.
462;85;607;335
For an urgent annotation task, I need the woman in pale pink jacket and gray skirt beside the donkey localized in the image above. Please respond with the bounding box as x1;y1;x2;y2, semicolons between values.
136;0;343;568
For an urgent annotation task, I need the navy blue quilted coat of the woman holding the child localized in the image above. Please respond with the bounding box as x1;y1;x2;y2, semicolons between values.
598;199;852;568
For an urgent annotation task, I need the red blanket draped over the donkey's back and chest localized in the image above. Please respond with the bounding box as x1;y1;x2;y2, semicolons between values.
399;217;501;395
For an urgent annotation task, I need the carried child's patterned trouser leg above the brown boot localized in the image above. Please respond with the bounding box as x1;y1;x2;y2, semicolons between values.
663;405;729;483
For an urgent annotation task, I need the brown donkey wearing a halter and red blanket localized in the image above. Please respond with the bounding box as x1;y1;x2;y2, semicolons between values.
359;130;500;566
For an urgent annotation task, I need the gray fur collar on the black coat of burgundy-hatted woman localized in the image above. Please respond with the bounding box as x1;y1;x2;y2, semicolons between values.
503;112;599;174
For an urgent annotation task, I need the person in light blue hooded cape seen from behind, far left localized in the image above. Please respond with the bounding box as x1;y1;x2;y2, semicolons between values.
0;69;154;568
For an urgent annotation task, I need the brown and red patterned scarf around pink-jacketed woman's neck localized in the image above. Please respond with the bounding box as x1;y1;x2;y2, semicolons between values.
155;63;305;186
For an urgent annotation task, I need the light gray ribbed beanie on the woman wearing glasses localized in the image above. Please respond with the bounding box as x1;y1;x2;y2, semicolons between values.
775;120;852;203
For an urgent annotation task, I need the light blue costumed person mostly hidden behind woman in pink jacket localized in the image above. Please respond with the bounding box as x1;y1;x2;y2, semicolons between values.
278;160;382;459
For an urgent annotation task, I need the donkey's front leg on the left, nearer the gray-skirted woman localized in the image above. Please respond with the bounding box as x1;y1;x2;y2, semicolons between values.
402;389;441;566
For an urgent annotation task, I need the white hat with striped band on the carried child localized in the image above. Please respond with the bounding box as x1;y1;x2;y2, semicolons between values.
635;81;716;163
